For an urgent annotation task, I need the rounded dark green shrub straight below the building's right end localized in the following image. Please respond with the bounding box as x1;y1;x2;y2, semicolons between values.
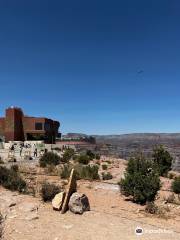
39;152;60;167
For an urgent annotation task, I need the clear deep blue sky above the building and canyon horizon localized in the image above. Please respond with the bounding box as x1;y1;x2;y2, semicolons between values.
0;0;180;134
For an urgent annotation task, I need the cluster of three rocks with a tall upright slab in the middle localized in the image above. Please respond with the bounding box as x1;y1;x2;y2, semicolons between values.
52;169;90;214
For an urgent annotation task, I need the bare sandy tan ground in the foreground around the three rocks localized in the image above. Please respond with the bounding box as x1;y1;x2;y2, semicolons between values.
0;158;180;240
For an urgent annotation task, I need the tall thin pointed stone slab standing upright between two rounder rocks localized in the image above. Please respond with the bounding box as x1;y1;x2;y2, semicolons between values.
61;169;77;214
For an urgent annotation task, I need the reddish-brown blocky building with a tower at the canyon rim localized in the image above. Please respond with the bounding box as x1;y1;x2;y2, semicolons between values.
0;107;60;143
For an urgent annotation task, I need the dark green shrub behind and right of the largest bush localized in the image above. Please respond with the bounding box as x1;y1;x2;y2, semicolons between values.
153;146;173;176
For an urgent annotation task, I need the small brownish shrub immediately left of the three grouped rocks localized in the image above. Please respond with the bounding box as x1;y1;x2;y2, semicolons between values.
41;182;61;202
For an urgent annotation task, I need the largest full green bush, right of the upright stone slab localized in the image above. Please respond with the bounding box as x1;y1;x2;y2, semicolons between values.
119;155;160;204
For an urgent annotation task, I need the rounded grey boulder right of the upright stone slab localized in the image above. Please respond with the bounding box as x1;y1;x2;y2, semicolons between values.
68;192;90;214
